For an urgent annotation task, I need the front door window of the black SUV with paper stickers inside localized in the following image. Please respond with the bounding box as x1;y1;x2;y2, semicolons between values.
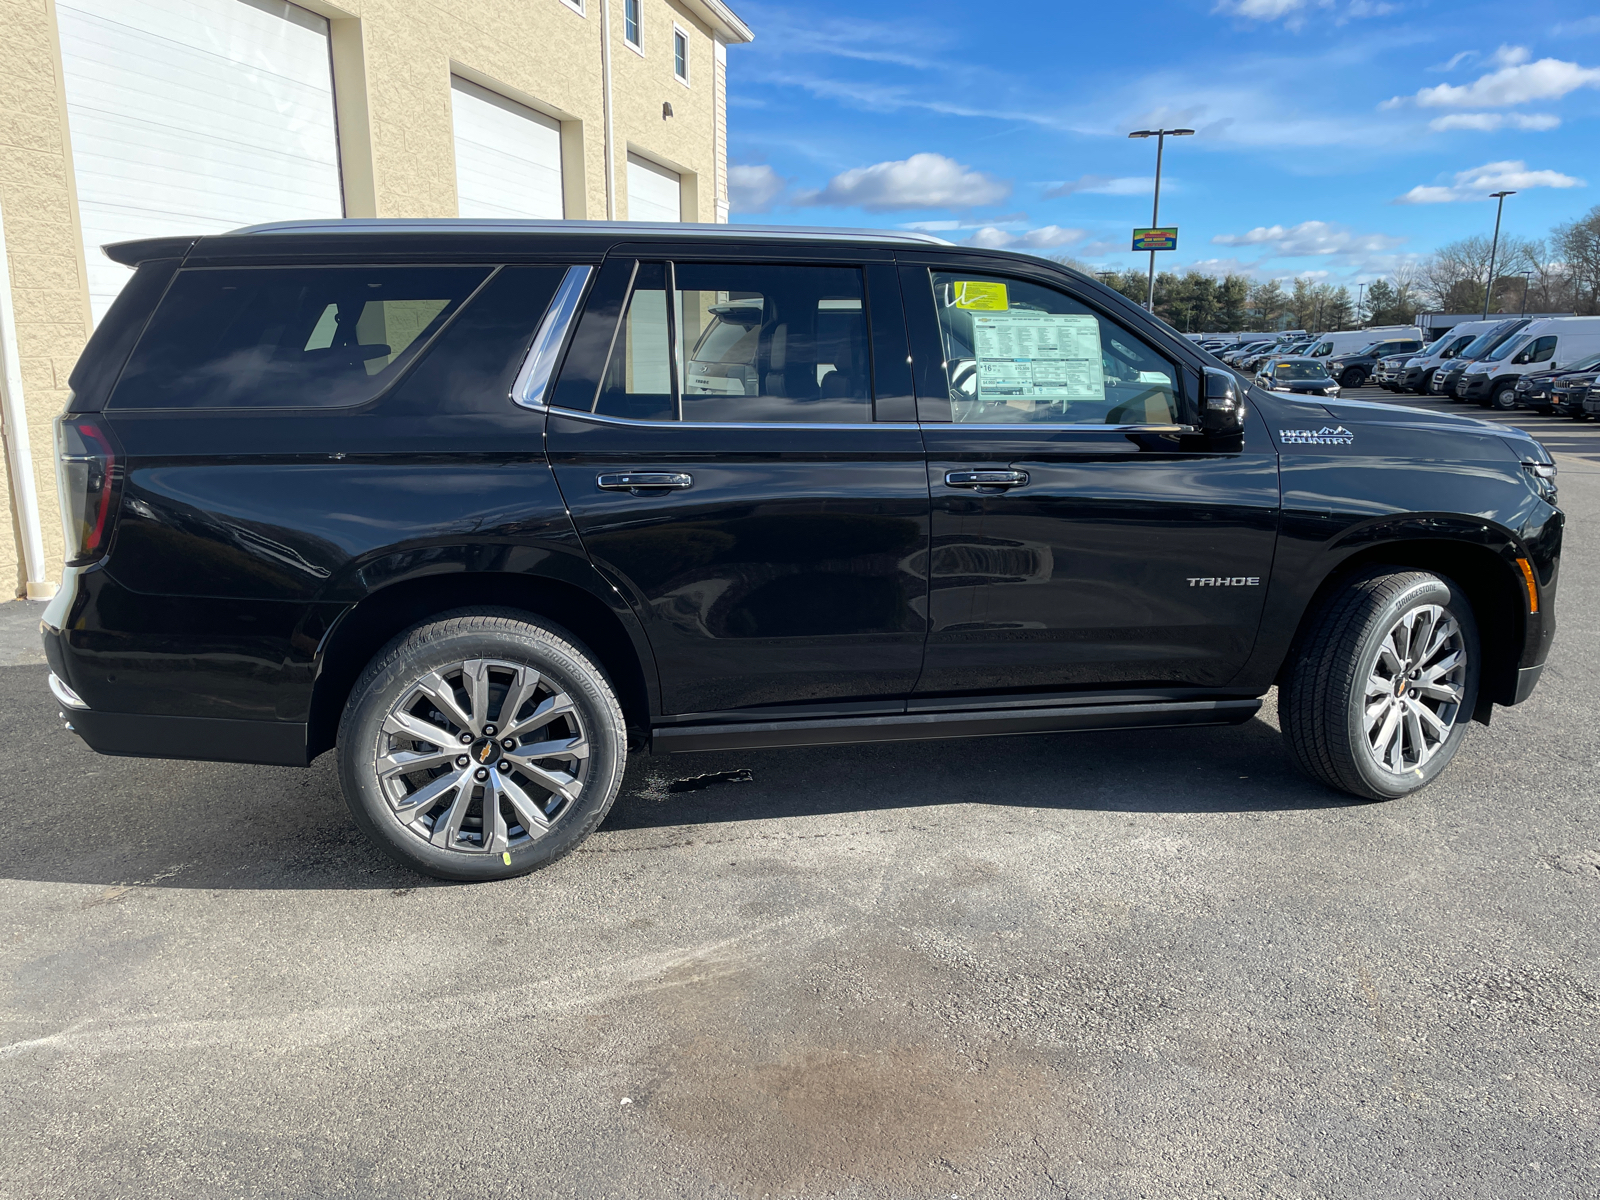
933;270;1179;426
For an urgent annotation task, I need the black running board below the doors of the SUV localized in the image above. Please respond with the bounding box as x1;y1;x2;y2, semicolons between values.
651;698;1261;754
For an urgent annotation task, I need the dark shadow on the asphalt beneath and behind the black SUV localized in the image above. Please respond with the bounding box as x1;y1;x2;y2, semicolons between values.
0;666;1352;907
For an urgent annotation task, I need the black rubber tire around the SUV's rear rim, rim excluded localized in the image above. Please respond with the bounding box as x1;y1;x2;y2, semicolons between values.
338;616;627;882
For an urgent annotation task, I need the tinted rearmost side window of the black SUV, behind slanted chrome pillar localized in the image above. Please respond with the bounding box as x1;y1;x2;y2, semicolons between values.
110;267;491;408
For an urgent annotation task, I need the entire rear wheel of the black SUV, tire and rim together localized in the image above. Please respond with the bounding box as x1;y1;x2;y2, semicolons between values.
338;608;627;882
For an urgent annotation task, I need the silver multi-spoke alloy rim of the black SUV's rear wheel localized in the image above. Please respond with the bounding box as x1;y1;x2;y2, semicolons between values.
373;659;589;854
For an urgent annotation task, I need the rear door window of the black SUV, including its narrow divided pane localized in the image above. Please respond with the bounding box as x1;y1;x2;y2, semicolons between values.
595;264;872;424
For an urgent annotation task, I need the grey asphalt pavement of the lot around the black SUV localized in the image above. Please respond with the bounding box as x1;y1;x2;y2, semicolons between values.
0;394;1600;1200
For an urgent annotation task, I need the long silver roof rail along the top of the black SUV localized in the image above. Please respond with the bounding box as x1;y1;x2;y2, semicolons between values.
229;218;952;246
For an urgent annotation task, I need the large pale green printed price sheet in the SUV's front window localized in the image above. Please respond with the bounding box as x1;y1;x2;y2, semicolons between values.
973;310;1106;400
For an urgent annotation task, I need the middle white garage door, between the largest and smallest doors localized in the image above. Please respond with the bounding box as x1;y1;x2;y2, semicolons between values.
450;77;566;221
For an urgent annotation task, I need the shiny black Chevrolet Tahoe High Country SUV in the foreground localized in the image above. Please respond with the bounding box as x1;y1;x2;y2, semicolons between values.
43;221;1563;880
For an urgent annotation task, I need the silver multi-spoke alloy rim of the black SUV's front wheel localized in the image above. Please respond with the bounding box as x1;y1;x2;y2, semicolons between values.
1362;605;1467;774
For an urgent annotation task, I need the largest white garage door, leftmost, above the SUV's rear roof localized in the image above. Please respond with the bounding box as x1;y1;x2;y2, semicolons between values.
56;0;344;322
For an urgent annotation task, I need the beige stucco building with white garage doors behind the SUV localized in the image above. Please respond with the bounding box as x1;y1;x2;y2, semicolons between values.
0;0;752;600
